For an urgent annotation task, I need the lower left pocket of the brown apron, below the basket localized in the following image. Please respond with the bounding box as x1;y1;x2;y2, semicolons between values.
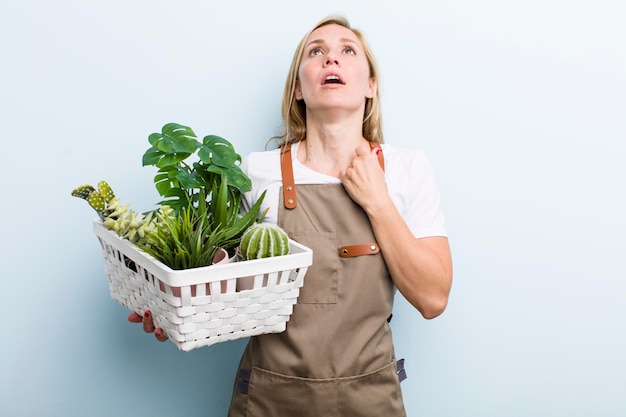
248;368;338;417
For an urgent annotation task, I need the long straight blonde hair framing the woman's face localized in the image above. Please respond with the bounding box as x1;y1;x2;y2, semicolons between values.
272;16;383;146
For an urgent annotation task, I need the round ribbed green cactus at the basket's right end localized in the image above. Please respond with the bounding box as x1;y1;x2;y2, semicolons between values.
239;223;289;259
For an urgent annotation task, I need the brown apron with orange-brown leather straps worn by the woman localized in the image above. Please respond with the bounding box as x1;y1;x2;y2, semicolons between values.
229;147;406;417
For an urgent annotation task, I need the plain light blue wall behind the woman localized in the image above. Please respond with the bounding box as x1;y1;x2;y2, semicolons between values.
0;0;626;417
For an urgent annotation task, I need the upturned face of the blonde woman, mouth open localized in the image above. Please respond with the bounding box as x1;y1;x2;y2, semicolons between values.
296;24;376;115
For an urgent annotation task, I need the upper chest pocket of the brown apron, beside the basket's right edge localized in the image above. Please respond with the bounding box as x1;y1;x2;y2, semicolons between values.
290;231;340;304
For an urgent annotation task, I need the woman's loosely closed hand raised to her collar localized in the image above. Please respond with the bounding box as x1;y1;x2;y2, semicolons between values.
341;145;387;211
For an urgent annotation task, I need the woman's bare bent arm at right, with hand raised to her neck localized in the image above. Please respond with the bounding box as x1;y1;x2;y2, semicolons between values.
342;146;452;319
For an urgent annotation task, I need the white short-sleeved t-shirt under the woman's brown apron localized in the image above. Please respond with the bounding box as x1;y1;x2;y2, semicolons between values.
241;142;446;238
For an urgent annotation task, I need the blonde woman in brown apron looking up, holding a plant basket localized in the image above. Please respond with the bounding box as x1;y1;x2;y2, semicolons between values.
134;17;452;417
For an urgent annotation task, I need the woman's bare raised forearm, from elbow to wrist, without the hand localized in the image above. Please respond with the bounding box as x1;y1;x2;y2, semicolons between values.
366;198;452;319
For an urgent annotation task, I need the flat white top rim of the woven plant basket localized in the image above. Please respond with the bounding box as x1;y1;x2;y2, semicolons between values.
93;218;313;287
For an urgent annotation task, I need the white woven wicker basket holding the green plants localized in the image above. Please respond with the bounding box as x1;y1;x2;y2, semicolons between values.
93;220;313;351
